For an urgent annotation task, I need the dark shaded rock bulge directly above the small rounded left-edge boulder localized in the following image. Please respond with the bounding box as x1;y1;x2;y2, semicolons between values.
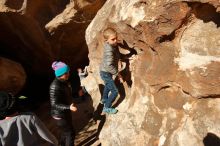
0;13;53;74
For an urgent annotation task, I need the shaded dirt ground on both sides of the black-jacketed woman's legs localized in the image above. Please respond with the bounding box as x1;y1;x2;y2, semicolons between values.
34;97;105;146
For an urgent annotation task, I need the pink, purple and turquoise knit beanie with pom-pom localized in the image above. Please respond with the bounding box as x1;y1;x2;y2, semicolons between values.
52;61;70;77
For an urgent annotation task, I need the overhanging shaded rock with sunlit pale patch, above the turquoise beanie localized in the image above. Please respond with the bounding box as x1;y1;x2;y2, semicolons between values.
45;0;105;68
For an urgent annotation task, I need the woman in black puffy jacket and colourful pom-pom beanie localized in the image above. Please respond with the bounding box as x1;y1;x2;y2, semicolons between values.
50;61;77;146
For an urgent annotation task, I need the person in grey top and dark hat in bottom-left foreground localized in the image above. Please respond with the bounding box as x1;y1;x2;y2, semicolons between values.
0;91;58;146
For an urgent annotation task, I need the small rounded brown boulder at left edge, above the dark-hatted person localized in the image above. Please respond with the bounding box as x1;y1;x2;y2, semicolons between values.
0;57;26;95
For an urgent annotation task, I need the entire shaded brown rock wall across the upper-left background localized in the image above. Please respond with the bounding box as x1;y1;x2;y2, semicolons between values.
0;0;105;95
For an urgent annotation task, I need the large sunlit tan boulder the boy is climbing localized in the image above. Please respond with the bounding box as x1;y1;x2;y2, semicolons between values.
83;0;220;146
